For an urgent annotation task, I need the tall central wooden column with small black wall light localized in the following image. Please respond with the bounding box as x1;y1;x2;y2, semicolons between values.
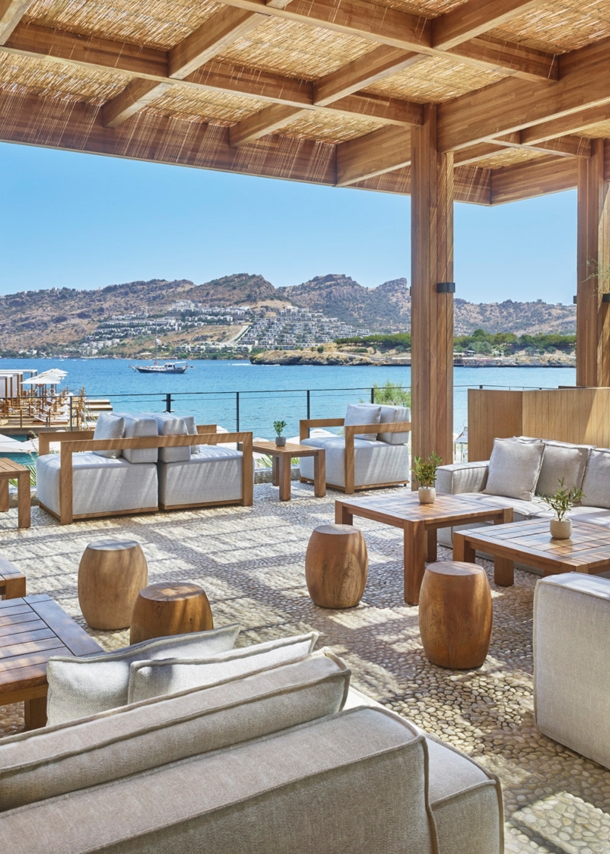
411;105;453;474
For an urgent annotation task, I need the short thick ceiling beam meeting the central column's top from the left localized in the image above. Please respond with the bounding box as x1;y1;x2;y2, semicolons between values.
336;127;411;187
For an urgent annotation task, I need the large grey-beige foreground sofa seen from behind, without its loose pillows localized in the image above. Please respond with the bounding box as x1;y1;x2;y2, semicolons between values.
0;648;503;854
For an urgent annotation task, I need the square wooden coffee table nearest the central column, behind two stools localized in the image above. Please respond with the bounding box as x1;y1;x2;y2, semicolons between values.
335;490;513;605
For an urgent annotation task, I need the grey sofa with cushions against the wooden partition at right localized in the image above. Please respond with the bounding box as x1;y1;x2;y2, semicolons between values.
436;436;610;547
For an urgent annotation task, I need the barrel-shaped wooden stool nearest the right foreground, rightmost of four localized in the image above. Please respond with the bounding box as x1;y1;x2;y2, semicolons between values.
419;561;492;670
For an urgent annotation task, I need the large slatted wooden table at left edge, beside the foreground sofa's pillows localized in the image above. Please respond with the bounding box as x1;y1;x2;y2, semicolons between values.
0;593;102;729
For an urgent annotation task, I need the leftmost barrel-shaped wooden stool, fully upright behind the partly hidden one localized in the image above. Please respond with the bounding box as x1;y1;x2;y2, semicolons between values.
78;540;148;629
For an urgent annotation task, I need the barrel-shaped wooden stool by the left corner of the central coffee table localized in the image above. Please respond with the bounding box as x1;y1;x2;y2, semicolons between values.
305;525;369;608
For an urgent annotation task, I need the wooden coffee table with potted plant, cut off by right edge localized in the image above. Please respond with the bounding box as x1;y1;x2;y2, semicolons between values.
453;519;610;587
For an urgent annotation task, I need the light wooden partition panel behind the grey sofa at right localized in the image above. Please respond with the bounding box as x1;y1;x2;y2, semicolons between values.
468;388;610;461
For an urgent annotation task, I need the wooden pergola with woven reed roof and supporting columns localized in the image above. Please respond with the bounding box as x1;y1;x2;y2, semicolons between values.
0;0;610;460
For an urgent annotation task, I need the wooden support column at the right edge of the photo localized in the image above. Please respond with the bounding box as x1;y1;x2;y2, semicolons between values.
576;139;610;386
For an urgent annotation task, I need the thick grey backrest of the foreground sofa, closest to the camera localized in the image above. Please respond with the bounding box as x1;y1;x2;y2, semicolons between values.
0;709;432;854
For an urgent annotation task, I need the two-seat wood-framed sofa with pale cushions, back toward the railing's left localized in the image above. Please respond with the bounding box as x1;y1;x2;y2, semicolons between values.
36;413;253;524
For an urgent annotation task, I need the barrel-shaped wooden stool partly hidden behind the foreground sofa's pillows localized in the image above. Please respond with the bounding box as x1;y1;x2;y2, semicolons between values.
129;582;214;643
